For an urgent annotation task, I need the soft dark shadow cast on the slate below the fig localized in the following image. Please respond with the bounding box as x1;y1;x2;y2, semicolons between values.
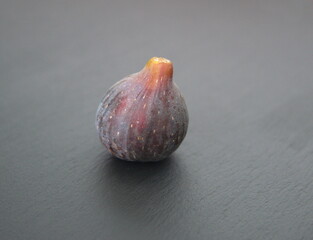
100;154;183;224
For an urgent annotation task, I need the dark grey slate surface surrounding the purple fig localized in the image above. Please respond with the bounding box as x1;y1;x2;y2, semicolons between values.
0;0;313;240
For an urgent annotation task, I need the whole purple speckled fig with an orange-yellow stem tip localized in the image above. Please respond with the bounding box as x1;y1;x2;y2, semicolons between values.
96;57;188;162
